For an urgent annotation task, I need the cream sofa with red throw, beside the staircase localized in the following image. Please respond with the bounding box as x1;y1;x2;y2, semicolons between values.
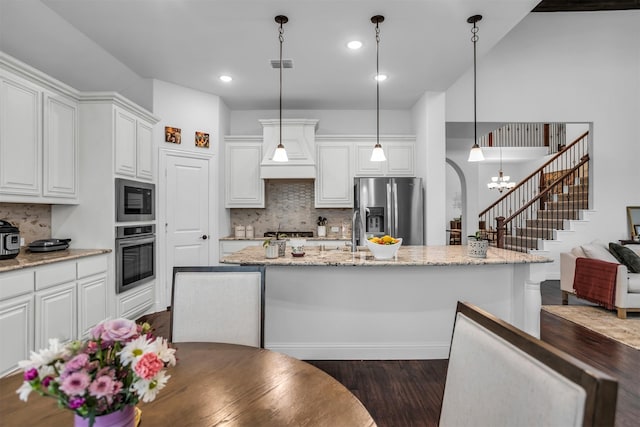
560;241;640;319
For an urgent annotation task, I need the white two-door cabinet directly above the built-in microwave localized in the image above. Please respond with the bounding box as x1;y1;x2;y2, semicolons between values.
114;107;153;180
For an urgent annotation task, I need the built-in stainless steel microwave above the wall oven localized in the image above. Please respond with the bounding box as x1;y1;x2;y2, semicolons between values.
116;178;156;222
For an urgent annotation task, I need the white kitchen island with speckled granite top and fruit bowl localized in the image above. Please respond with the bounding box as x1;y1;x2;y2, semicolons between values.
222;246;551;360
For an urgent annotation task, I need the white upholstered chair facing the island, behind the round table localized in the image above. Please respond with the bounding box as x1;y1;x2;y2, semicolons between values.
170;266;265;347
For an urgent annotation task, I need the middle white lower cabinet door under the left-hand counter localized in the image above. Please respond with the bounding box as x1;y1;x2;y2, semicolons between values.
35;282;77;348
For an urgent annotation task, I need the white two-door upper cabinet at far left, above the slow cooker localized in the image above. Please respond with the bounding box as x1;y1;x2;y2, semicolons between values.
0;65;78;204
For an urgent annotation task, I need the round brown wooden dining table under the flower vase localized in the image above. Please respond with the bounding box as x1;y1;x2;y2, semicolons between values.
0;343;376;427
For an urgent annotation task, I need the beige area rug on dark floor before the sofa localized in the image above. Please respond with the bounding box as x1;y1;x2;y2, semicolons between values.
542;305;640;350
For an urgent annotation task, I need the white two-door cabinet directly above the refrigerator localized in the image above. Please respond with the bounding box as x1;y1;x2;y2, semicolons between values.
355;137;415;176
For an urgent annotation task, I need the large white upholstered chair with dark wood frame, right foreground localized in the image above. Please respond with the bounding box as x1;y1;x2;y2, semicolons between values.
440;302;618;427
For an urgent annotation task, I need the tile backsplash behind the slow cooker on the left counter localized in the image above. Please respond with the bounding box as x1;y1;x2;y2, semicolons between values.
0;203;51;245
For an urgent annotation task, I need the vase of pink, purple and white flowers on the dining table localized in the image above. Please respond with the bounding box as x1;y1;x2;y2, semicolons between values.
17;319;176;427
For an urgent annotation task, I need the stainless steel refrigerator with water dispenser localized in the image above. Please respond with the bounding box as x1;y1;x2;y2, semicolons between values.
352;177;424;246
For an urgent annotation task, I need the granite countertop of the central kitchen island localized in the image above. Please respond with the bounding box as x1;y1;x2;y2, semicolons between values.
221;245;552;266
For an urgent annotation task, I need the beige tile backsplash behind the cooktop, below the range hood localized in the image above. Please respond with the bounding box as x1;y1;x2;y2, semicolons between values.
229;179;352;238
